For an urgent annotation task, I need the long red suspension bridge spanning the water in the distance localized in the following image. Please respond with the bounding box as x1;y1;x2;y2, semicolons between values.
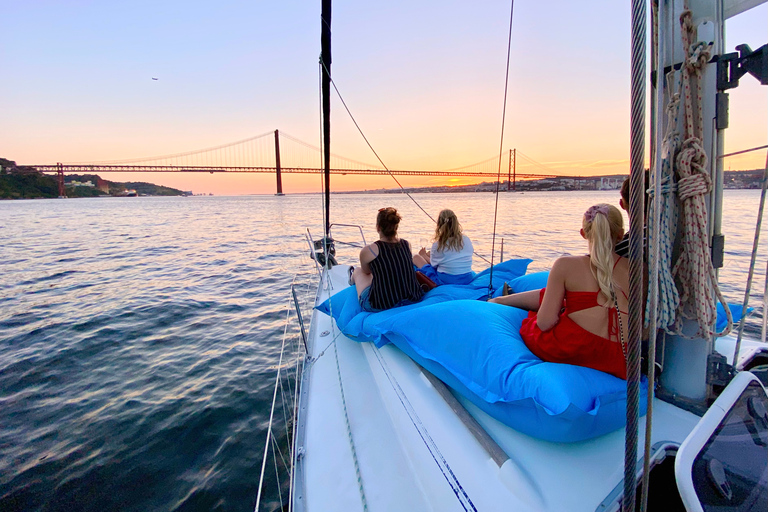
24;130;558;196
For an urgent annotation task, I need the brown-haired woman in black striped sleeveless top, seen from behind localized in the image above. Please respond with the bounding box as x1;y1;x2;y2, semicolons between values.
351;207;424;312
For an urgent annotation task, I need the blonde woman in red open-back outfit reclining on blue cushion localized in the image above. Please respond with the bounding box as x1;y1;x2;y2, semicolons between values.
491;204;629;379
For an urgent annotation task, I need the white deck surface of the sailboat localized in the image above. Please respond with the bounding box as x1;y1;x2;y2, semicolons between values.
296;266;699;512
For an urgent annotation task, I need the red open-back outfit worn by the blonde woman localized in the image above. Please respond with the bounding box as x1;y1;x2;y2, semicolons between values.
520;289;627;379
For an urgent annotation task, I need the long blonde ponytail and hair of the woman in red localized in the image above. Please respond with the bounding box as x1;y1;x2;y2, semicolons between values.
581;203;624;298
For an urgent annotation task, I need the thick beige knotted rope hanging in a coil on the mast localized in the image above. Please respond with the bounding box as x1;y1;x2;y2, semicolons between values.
672;10;733;339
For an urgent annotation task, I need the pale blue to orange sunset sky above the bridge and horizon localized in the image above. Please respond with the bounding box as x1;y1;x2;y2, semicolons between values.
0;0;768;194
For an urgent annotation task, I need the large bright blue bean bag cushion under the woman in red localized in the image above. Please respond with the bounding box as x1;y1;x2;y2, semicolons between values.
318;262;646;442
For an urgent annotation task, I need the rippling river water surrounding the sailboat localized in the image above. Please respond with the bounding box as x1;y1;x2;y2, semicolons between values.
0;191;768;511
